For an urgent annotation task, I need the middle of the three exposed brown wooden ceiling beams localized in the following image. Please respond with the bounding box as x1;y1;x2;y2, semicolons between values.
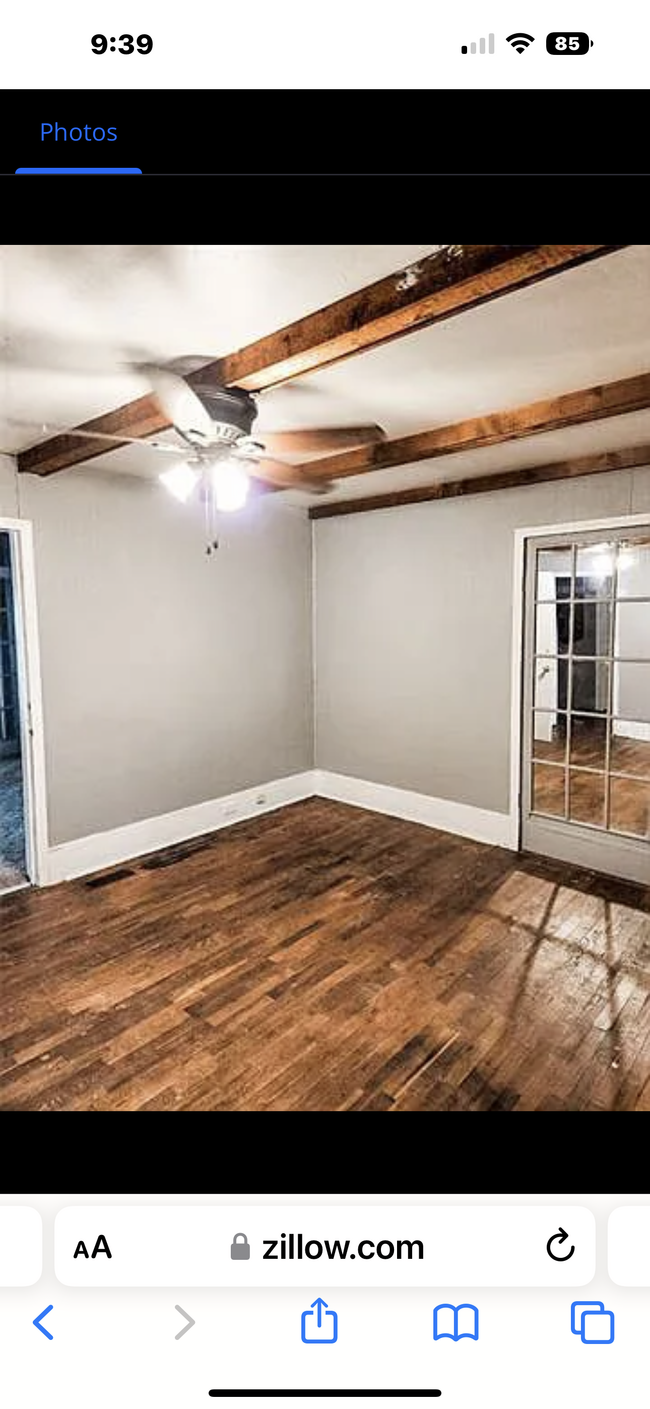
299;372;650;480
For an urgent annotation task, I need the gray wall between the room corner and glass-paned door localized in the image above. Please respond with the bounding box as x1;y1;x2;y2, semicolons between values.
313;469;650;813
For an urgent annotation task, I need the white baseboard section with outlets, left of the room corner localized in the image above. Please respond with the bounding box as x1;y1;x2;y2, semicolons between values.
44;771;314;885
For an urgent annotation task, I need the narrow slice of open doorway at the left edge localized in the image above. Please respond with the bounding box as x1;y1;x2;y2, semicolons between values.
0;531;27;892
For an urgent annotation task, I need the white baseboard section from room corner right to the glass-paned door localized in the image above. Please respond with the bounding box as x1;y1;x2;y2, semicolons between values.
313;768;516;851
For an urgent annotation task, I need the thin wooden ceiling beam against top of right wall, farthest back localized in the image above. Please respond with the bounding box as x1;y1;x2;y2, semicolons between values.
309;444;650;519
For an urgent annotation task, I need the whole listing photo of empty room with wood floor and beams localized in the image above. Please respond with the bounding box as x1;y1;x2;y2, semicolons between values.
0;244;650;1113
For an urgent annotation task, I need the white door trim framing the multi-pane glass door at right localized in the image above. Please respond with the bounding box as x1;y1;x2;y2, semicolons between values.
510;513;650;851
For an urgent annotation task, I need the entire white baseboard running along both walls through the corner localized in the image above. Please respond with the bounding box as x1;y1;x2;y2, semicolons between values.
42;768;516;885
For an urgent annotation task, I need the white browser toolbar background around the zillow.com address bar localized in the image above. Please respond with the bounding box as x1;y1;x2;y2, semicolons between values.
0;1193;650;1409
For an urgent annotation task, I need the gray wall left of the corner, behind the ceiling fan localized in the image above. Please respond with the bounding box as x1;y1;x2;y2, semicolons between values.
0;458;313;844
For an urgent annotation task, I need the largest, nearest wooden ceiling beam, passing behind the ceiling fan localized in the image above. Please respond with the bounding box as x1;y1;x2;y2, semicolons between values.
17;245;623;483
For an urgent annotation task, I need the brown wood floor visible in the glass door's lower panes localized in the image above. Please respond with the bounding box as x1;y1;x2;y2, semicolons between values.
533;731;650;837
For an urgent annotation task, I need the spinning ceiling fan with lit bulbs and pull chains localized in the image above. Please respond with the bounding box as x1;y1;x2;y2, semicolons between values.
2;358;385;551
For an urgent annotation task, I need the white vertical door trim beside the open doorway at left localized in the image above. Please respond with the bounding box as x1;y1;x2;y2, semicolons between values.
0;519;48;885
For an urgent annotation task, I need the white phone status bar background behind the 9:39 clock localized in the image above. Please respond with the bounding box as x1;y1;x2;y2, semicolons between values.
0;0;642;87
